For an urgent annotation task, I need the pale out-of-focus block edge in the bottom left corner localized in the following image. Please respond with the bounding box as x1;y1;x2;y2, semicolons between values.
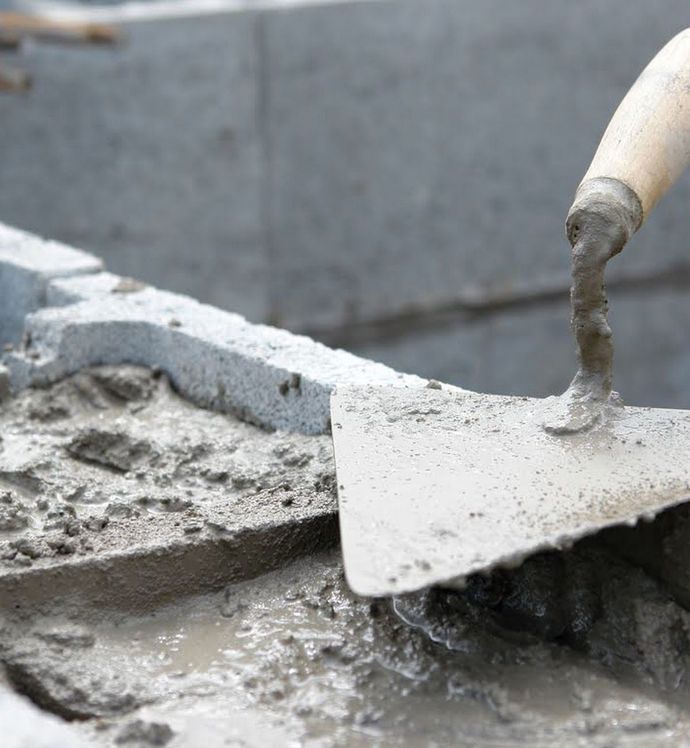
0;684;93;748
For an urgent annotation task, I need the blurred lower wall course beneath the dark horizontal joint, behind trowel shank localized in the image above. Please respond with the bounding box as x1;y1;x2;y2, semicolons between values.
353;289;690;408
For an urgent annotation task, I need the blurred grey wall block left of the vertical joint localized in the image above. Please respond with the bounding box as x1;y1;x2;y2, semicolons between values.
0;10;267;321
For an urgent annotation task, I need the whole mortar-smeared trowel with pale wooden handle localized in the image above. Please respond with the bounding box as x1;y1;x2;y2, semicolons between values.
331;30;690;596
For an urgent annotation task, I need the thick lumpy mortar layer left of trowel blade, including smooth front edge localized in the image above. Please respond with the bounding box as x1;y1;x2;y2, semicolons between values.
0;367;335;609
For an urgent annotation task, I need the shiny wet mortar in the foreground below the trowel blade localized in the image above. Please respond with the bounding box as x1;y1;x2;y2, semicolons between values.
0;547;690;748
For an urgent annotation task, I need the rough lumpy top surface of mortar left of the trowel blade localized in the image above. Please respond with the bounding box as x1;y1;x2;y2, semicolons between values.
0;366;335;573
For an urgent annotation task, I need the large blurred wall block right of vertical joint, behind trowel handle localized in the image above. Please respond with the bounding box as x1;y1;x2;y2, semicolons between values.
263;0;690;330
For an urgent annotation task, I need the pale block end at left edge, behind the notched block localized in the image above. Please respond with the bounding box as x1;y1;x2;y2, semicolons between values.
0;223;102;345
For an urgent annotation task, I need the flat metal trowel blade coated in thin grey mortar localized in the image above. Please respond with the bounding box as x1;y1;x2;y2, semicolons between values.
331;386;690;596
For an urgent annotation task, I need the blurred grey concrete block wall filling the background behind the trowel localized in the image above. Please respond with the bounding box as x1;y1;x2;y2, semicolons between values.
0;0;690;406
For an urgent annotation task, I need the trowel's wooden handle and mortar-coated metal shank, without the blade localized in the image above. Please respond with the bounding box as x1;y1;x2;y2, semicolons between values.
566;29;690;401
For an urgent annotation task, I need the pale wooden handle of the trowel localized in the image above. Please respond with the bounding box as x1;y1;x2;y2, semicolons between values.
571;29;690;238
